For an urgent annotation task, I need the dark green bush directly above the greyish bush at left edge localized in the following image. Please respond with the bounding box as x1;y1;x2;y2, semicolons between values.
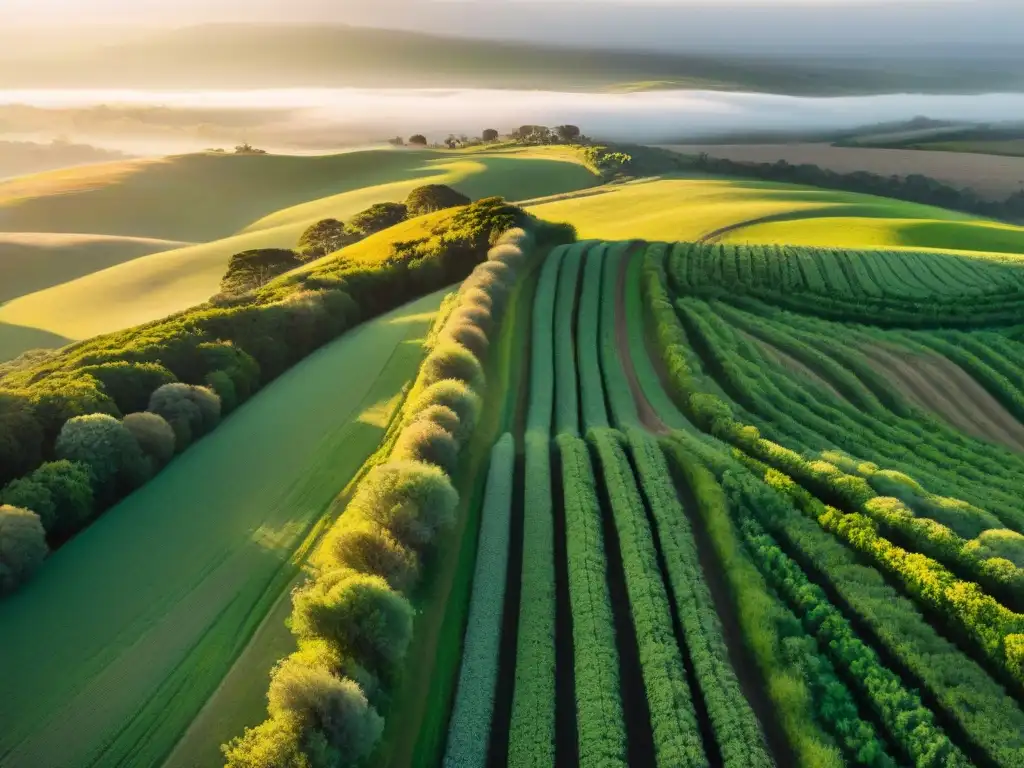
0;461;93;536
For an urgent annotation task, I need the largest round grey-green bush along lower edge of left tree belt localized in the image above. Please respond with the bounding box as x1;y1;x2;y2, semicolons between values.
56;417;151;497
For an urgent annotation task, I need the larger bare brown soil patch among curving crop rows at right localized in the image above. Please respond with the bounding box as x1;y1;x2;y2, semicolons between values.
861;344;1024;453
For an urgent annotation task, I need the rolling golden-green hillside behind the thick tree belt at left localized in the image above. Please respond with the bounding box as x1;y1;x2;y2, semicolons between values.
0;150;596;359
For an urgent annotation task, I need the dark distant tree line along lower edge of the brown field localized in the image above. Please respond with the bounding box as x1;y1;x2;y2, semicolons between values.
694;153;1024;221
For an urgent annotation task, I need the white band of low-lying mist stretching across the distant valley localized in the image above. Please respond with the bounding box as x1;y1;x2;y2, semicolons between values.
8;88;1024;155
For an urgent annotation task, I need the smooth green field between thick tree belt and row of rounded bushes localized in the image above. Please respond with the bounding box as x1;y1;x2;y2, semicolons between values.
0;292;443;766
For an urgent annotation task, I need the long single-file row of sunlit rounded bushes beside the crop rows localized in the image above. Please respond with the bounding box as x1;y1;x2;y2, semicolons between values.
223;229;544;768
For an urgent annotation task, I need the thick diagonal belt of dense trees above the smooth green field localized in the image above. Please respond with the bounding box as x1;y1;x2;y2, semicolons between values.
0;199;544;593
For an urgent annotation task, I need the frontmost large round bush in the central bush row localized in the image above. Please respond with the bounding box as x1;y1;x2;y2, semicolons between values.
267;656;384;762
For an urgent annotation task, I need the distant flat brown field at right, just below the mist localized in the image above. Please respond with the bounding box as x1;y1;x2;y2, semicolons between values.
664;143;1024;200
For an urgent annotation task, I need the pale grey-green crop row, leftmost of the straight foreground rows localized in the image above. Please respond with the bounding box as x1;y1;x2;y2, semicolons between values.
444;432;515;768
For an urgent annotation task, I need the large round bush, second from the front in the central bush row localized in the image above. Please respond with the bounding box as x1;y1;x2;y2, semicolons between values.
292;568;414;677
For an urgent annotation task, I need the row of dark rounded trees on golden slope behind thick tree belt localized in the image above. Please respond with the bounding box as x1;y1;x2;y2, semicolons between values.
220;184;472;296
